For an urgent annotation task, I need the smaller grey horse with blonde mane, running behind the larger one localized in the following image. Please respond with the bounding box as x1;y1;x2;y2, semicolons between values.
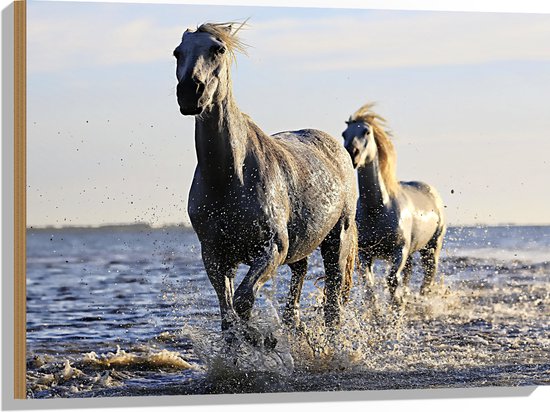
342;104;446;306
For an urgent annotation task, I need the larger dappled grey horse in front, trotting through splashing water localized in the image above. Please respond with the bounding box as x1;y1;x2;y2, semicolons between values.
174;23;357;343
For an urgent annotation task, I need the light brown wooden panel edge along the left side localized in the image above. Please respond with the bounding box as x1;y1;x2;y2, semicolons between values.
14;0;27;399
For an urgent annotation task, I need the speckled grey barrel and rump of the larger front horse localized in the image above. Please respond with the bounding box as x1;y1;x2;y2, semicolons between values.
257;129;357;261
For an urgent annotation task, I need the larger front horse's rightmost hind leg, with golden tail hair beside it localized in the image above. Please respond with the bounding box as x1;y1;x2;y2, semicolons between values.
321;218;357;327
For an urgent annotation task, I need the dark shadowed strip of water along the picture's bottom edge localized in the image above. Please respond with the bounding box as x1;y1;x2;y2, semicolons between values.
83;365;550;397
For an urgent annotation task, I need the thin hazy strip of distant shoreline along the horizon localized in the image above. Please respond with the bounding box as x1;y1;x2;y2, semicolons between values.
27;223;550;232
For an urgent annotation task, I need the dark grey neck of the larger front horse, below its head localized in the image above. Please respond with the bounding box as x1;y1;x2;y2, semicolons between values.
195;84;248;187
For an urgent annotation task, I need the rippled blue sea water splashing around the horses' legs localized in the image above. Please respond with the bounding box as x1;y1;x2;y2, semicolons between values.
27;226;550;398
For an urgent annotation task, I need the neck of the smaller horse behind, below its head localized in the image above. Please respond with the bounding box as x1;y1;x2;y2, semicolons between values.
357;156;390;215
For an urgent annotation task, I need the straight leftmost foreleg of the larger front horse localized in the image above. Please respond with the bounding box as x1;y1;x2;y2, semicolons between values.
202;246;238;331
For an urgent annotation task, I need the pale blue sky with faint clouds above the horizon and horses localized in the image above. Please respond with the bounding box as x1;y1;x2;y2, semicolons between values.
27;1;550;226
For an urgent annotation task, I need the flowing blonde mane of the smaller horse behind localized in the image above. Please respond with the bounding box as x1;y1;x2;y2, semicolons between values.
347;103;399;195
